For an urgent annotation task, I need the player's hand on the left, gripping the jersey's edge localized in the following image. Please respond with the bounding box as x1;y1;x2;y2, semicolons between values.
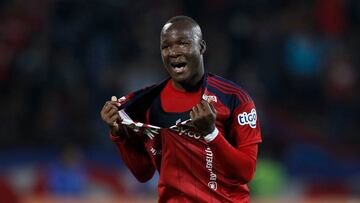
100;96;122;136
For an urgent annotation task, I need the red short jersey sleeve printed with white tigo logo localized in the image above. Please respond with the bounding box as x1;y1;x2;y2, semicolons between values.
229;100;262;147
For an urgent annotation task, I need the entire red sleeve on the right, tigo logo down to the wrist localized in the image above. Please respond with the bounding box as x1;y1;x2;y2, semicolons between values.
209;100;261;184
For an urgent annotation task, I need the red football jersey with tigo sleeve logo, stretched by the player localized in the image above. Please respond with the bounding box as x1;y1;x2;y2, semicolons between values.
112;75;261;202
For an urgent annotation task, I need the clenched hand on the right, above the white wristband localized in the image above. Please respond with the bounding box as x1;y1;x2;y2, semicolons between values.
190;100;216;136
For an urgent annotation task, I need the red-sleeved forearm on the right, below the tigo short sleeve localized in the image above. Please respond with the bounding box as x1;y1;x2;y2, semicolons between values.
209;133;258;184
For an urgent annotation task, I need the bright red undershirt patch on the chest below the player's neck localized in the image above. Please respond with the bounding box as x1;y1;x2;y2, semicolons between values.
160;80;202;112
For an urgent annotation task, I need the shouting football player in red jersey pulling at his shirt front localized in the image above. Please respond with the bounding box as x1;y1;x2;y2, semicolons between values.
101;16;261;202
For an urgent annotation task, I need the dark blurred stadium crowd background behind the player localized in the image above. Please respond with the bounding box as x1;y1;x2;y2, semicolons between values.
0;0;360;203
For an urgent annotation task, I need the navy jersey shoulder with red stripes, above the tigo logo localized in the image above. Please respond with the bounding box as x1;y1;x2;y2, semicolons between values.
206;74;252;104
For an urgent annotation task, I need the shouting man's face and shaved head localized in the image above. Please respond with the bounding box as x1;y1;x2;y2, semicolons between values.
160;21;206;86
